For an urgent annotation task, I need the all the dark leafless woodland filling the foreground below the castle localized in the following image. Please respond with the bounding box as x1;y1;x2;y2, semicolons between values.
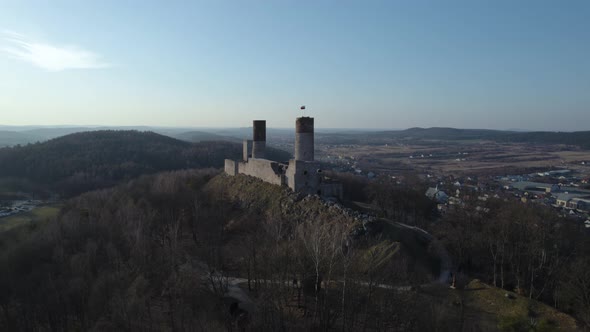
0;169;590;331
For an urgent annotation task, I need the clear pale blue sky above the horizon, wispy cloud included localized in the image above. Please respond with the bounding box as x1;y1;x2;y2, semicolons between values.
0;0;590;130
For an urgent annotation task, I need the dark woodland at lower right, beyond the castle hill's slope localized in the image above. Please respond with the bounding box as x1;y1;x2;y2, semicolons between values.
367;178;590;330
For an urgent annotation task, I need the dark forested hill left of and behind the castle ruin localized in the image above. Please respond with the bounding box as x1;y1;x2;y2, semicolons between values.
0;130;290;195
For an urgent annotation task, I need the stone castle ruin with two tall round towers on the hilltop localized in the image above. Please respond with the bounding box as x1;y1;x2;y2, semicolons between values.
225;117;342;198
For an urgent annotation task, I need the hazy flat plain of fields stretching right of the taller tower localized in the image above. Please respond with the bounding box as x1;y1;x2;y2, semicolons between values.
317;140;590;175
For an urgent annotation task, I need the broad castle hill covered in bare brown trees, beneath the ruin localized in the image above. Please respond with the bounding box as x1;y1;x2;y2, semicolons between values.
0;170;575;331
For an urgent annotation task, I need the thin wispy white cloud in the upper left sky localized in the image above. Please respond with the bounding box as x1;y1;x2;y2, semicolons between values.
0;31;110;71
